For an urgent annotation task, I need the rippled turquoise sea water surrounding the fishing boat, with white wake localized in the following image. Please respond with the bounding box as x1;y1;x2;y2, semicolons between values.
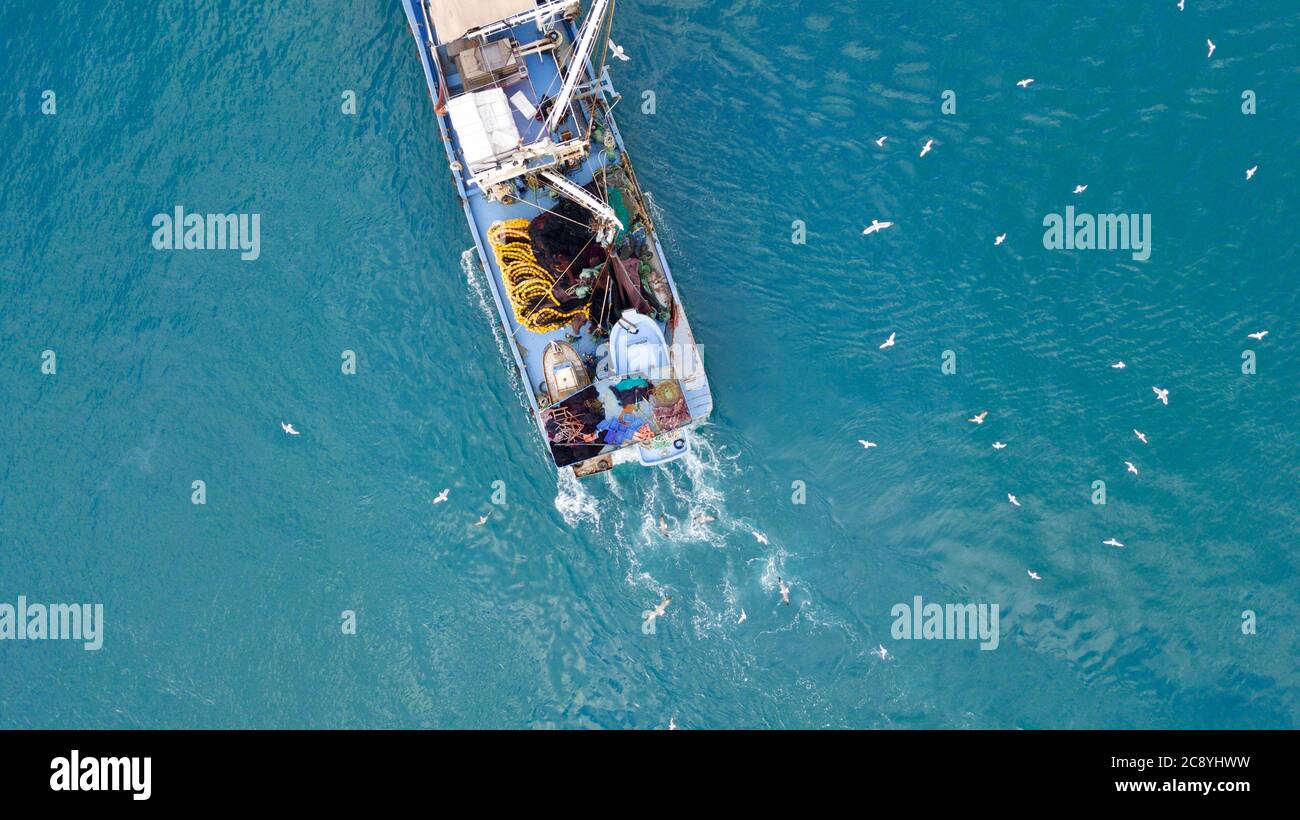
0;0;1300;728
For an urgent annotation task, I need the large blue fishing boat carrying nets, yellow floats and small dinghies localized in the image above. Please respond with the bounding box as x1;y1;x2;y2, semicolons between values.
402;0;714;477
